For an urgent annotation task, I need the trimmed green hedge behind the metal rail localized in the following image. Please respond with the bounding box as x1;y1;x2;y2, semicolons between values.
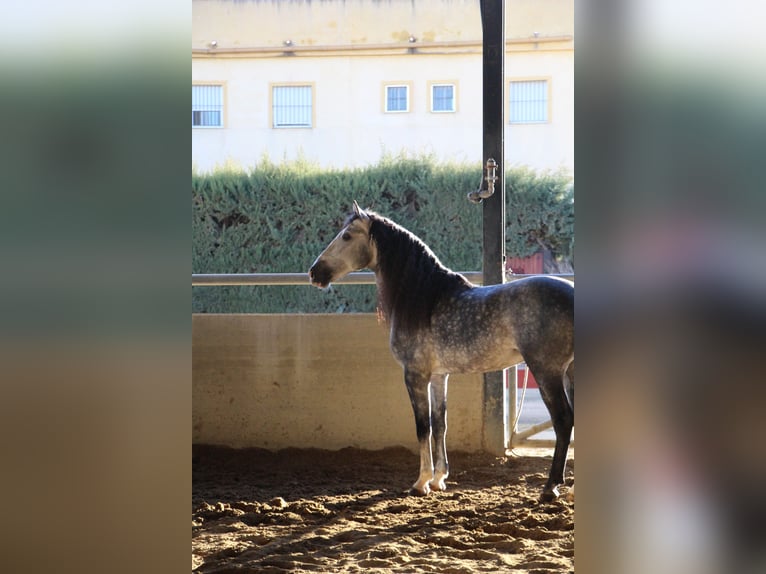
192;156;574;313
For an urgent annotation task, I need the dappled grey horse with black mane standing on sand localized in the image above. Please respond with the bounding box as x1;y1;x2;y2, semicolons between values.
309;201;574;501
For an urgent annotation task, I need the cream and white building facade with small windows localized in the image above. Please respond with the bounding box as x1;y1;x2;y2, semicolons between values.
192;0;574;174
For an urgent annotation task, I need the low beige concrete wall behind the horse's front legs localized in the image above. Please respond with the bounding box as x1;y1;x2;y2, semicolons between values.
192;314;482;451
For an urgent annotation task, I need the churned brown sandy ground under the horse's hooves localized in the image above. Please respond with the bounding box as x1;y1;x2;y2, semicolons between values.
192;446;574;573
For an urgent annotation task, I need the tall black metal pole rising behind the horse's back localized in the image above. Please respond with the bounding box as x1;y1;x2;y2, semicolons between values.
480;0;508;455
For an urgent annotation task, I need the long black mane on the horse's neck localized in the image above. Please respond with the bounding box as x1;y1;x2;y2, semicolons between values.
366;211;471;331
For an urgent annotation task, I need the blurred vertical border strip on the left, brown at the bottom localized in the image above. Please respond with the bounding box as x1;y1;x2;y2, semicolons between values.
0;0;191;572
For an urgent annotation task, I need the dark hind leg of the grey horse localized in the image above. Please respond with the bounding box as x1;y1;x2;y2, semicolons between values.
532;369;574;501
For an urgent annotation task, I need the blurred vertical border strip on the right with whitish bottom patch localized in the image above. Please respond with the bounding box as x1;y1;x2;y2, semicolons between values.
575;0;766;574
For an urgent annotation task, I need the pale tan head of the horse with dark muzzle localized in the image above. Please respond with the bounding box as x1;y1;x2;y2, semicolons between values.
309;201;377;288
